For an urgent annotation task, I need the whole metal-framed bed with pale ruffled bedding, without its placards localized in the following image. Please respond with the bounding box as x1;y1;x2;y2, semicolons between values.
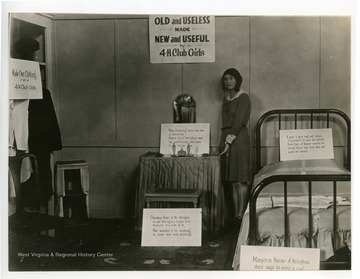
233;109;351;270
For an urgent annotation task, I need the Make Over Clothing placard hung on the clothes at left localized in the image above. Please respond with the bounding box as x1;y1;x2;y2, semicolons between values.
9;58;42;100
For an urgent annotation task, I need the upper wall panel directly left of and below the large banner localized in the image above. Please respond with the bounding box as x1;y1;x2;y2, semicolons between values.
116;19;182;146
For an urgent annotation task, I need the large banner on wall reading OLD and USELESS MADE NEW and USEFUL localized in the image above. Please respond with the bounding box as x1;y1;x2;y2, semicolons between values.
149;15;215;63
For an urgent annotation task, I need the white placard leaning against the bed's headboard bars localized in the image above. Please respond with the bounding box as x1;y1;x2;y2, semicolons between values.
280;128;334;161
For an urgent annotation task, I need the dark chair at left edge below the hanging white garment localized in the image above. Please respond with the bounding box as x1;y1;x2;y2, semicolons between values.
9;153;63;240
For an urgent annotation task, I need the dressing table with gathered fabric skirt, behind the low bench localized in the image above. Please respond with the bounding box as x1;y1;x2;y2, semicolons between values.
135;156;225;231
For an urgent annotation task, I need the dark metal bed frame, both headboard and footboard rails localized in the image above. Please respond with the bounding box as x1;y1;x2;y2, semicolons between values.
249;109;351;269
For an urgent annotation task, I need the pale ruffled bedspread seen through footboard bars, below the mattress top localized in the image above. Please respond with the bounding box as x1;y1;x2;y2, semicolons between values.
233;197;351;270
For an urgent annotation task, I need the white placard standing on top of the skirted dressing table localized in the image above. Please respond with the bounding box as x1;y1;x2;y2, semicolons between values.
160;123;210;156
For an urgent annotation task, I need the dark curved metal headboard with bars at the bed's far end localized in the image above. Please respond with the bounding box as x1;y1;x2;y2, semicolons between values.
255;109;351;172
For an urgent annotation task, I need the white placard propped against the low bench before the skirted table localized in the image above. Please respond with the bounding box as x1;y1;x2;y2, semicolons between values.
141;208;202;246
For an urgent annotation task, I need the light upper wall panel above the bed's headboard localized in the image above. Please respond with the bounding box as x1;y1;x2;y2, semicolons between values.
250;17;320;149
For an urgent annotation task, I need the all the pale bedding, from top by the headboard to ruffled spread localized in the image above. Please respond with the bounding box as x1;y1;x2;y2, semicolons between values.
233;160;351;270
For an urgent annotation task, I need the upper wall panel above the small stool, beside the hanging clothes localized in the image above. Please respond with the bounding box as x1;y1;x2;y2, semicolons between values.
55;20;116;144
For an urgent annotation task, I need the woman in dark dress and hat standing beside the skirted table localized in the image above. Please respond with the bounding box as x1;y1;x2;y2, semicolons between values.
219;68;251;223
